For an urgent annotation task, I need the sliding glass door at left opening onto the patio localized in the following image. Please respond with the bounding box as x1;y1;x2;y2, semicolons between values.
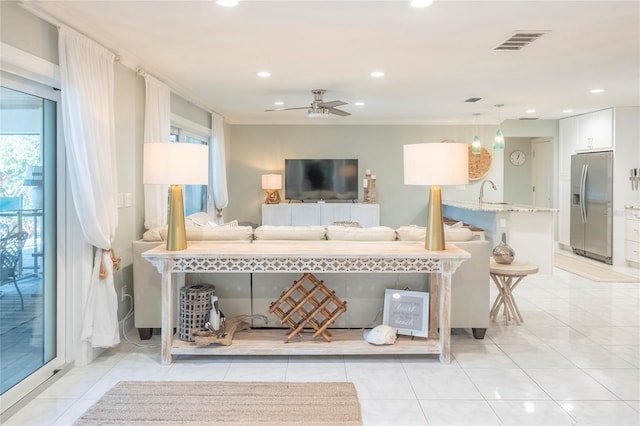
0;78;64;410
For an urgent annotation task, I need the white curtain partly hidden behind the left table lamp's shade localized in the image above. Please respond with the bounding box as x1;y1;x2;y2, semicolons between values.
144;75;171;229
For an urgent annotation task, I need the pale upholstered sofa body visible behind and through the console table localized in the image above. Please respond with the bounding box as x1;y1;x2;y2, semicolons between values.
132;239;492;339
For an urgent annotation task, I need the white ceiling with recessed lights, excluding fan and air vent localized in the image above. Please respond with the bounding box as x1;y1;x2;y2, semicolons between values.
25;0;640;124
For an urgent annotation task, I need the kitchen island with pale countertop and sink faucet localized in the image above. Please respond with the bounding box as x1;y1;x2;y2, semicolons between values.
442;201;558;274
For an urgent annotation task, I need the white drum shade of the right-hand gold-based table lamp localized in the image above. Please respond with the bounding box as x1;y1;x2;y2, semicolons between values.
403;142;469;185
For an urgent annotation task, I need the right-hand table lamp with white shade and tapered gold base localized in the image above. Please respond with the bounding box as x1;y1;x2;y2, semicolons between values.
403;142;469;251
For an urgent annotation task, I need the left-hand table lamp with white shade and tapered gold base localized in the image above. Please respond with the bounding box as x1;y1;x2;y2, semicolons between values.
142;142;209;251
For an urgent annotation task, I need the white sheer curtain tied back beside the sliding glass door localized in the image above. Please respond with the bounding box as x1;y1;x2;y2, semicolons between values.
58;26;120;347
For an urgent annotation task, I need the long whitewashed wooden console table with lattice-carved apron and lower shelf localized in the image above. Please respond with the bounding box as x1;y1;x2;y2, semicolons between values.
143;241;470;364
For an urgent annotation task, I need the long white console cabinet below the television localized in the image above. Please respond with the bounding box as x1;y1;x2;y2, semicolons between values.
262;202;380;228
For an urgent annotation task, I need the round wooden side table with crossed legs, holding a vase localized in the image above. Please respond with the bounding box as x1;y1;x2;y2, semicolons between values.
489;259;538;325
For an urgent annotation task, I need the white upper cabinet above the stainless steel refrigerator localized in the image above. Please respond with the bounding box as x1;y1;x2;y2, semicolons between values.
575;109;613;151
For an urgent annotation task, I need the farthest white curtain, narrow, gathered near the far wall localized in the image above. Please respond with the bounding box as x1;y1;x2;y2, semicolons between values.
207;113;229;225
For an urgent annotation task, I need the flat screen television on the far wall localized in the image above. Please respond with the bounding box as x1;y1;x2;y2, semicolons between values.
284;159;358;201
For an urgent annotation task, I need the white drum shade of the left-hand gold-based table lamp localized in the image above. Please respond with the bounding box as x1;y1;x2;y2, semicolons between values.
142;142;209;185
